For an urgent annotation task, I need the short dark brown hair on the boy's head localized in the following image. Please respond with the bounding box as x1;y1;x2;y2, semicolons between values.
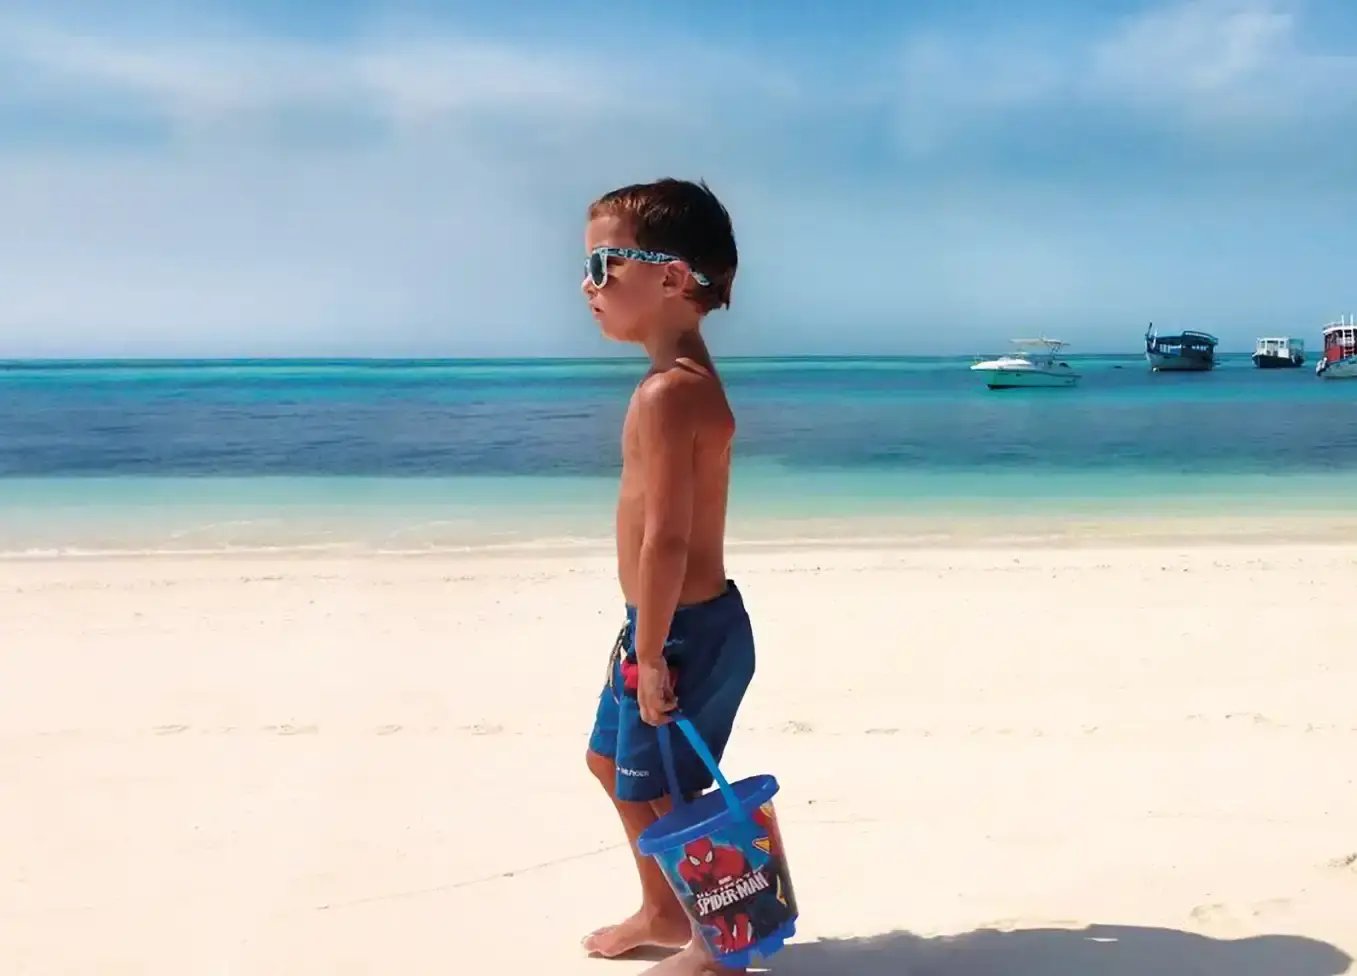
589;179;740;312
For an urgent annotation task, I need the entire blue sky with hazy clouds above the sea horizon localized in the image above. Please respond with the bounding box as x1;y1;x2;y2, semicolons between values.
0;0;1357;357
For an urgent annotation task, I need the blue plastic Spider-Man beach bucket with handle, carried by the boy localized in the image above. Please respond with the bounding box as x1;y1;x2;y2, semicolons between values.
636;715;797;969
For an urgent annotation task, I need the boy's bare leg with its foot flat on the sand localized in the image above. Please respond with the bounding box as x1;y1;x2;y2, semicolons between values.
584;749;692;956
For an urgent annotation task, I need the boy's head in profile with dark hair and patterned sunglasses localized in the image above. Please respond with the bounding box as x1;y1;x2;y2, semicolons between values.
582;179;738;342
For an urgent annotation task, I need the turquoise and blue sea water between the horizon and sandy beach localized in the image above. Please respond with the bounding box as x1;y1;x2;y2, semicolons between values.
0;356;1357;552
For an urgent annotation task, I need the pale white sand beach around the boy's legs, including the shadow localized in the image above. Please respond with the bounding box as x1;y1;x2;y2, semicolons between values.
0;542;1357;976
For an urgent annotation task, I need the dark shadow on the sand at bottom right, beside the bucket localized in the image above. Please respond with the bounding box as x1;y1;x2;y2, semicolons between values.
768;924;1352;976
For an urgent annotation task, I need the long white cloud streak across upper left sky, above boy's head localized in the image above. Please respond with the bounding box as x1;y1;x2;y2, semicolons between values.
0;16;798;137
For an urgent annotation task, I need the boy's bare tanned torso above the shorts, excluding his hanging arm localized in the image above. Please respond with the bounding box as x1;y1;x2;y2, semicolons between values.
617;356;735;604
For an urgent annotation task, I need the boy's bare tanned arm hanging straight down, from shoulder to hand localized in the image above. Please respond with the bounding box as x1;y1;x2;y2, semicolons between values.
635;376;696;725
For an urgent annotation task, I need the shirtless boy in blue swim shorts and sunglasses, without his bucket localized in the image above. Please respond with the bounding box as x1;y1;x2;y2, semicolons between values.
582;179;754;976
